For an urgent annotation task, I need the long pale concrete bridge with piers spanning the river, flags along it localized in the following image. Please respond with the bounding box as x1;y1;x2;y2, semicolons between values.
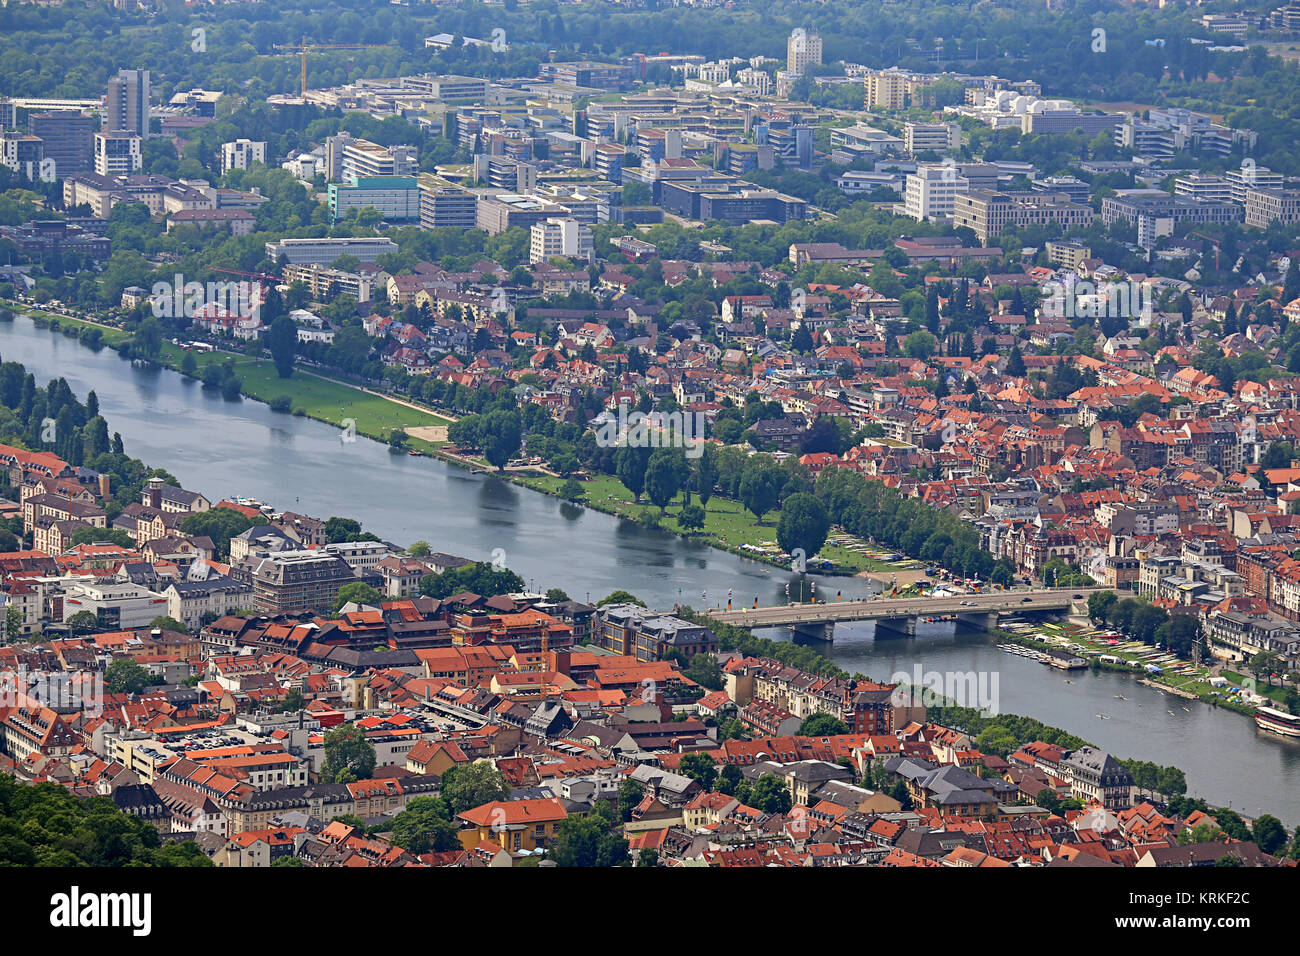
710;588;1100;641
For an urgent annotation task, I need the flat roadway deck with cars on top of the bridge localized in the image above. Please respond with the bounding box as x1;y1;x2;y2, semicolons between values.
712;588;1097;627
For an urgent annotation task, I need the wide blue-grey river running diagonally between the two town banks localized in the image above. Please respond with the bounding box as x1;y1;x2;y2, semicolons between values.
0;316;1300;827
